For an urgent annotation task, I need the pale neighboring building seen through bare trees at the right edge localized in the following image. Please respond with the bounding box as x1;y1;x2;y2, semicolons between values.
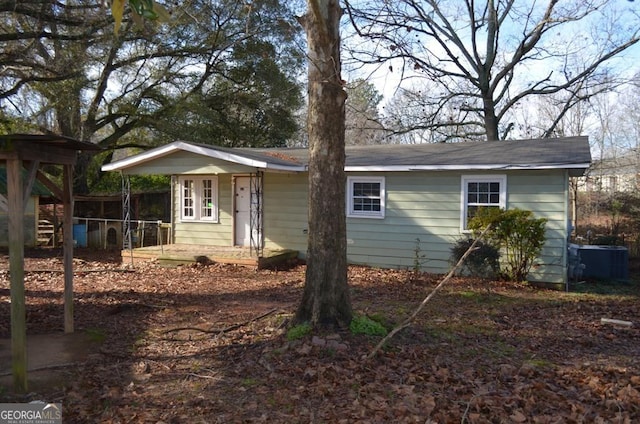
578;152;640;193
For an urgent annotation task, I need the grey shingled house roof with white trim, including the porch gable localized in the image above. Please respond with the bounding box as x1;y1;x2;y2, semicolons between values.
102;137;591;175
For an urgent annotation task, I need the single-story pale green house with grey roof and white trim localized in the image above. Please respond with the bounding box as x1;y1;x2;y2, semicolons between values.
102;137;591;283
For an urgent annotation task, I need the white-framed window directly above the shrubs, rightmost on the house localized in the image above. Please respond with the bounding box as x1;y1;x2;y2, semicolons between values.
460;175;507;231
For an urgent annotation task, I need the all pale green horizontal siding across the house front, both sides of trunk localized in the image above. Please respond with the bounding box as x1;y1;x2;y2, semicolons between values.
165;167;568;283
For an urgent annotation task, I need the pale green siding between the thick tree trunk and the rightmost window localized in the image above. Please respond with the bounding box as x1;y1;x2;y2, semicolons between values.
347;172;460;273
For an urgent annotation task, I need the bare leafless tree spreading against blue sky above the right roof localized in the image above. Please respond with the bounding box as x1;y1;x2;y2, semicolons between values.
345;0;640;141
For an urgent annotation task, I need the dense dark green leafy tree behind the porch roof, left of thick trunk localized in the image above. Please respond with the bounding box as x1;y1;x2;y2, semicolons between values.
149;40;303;147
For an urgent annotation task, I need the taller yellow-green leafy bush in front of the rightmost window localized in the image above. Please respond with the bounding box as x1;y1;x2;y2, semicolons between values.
469;208;547;281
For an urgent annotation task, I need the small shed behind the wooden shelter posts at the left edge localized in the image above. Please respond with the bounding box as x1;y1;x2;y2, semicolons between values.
0;165;52;247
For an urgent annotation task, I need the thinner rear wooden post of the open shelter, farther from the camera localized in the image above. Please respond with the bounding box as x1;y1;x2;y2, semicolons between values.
62;165;73;333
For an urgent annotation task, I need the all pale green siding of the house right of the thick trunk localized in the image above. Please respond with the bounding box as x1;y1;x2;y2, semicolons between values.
347;170;568;283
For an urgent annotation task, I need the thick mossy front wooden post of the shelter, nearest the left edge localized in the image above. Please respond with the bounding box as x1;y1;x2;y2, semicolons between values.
7;154;27;393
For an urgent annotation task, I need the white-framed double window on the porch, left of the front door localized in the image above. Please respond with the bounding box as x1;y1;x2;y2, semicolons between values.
178;176;218;222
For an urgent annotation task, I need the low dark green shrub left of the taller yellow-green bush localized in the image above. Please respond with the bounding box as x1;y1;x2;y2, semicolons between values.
451;239;500;279
